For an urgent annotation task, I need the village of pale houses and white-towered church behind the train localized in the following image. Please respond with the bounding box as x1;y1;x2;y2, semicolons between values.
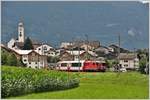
1;22;142;71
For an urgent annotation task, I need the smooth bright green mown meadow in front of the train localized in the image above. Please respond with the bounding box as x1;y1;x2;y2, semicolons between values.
9;72;149;99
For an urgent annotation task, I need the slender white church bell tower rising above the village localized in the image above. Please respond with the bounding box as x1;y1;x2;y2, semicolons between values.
18;22;25;43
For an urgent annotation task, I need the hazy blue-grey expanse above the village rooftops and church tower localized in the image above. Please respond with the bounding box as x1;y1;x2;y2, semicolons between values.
1;1;149;50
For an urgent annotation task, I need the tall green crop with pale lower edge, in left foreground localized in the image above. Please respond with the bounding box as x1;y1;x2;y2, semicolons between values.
1;66;79;98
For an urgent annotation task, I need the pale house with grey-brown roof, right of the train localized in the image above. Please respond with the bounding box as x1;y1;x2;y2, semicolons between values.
119;53;139;69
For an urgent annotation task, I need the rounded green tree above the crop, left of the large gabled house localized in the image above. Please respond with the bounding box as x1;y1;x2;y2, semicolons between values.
7;54;17;66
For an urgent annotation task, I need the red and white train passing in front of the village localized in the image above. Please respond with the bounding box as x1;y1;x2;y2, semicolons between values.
56;60;106;72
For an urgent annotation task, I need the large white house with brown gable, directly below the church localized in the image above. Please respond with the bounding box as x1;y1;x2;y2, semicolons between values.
15;50;47;68
